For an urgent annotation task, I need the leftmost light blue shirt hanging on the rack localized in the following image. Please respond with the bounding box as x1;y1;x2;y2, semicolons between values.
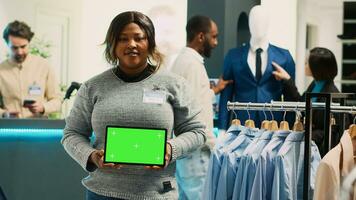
203;126;245;200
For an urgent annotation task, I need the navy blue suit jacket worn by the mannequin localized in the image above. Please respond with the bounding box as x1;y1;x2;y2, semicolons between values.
218;44;295;130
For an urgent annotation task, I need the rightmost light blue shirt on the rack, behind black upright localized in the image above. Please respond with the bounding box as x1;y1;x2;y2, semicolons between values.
271;132;320;200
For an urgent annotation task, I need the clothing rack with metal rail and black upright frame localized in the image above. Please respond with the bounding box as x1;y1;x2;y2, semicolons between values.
227;93;356;199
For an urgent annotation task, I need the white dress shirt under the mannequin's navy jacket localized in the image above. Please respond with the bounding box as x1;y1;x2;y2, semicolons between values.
247;41;268;77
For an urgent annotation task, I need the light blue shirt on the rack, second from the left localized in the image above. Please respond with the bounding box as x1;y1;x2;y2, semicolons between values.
215;128;261;200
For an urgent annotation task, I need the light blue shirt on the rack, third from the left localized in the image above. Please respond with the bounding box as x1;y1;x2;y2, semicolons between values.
232;130;273;199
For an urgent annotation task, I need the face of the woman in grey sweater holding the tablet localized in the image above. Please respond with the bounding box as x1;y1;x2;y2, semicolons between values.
115;23;149;75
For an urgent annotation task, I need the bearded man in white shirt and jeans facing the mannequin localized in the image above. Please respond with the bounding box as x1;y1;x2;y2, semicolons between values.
171;16;231;200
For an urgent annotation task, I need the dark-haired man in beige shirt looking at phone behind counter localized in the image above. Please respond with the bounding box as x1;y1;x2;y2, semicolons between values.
0;20;61;118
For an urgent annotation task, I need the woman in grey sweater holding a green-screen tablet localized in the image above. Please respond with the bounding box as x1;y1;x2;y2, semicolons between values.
62;11;205;200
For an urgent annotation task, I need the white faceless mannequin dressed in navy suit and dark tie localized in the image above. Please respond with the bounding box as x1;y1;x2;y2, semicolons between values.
219;6;295;130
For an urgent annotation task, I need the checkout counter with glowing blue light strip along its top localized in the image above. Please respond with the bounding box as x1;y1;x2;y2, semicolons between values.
0;119;87;200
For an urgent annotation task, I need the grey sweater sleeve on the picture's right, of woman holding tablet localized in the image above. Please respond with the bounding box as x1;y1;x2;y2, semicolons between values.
168;79;206;161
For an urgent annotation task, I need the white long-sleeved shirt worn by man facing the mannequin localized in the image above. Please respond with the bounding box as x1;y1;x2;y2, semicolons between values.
171;47;215;148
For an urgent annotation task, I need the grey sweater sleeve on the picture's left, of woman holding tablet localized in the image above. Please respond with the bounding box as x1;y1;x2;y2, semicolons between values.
61;84;96;171
